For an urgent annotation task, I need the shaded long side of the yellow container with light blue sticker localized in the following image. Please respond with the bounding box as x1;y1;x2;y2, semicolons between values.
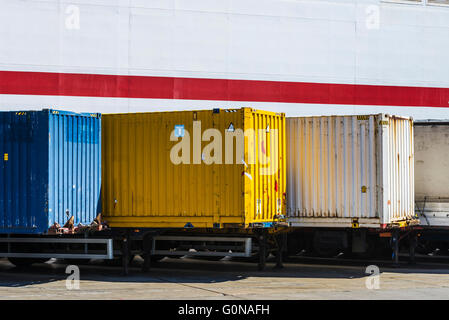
102;110;244;228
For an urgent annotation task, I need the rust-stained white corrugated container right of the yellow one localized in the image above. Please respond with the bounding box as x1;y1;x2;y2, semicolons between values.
287;114;416;227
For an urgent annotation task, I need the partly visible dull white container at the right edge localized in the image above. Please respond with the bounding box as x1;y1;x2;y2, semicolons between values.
414;121;449;227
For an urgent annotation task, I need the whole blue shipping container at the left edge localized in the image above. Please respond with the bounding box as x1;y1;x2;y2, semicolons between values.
0;110;101;234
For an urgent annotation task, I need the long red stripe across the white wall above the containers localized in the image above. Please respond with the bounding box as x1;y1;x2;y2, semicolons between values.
0;71;449;107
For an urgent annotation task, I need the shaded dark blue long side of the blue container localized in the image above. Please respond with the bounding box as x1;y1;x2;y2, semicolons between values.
0;112;47;233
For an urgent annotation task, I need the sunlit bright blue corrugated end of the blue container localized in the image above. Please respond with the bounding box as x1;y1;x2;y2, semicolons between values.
48;110;101;226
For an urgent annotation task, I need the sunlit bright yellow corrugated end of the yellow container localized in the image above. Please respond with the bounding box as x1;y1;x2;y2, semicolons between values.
243;109;286;227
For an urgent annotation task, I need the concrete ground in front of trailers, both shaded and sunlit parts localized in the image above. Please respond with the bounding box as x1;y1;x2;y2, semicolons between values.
0;257;449;300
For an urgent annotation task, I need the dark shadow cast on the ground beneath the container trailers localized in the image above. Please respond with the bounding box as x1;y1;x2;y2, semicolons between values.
0;257;449;287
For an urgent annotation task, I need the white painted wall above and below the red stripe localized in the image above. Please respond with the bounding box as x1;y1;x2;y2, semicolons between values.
0;0;449;119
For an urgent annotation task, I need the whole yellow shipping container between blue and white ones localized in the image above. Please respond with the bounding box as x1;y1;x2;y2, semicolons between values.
102;108;286;228
